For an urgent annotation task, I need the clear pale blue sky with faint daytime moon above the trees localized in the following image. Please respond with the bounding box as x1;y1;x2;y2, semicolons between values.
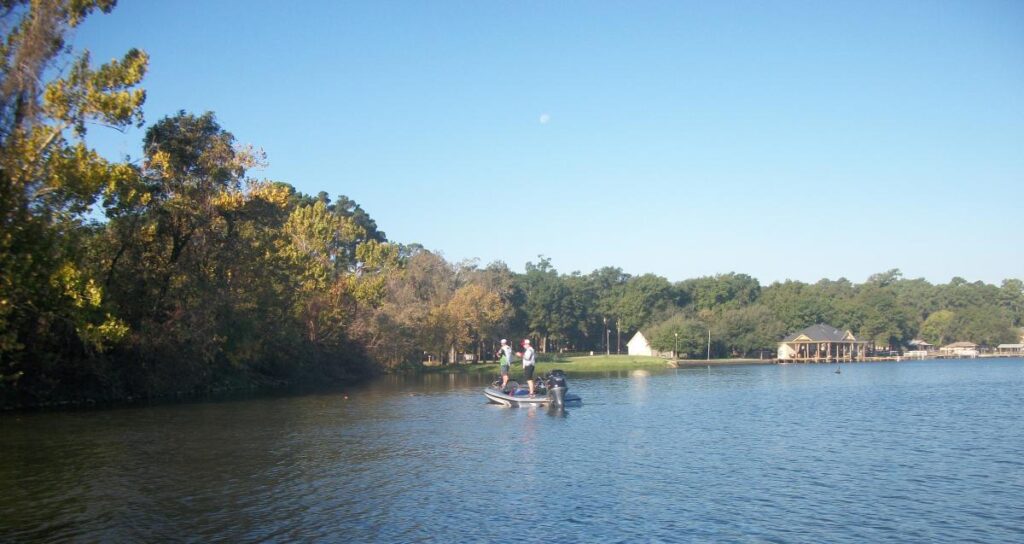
75;0;1024;284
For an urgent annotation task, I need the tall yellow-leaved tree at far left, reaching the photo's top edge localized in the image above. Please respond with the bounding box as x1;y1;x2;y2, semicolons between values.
0;0;147;402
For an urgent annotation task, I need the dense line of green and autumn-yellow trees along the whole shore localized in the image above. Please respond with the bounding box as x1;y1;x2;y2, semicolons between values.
0;0;1024;406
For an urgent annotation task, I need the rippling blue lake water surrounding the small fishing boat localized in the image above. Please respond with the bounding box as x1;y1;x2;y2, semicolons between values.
0;360;1024;543
